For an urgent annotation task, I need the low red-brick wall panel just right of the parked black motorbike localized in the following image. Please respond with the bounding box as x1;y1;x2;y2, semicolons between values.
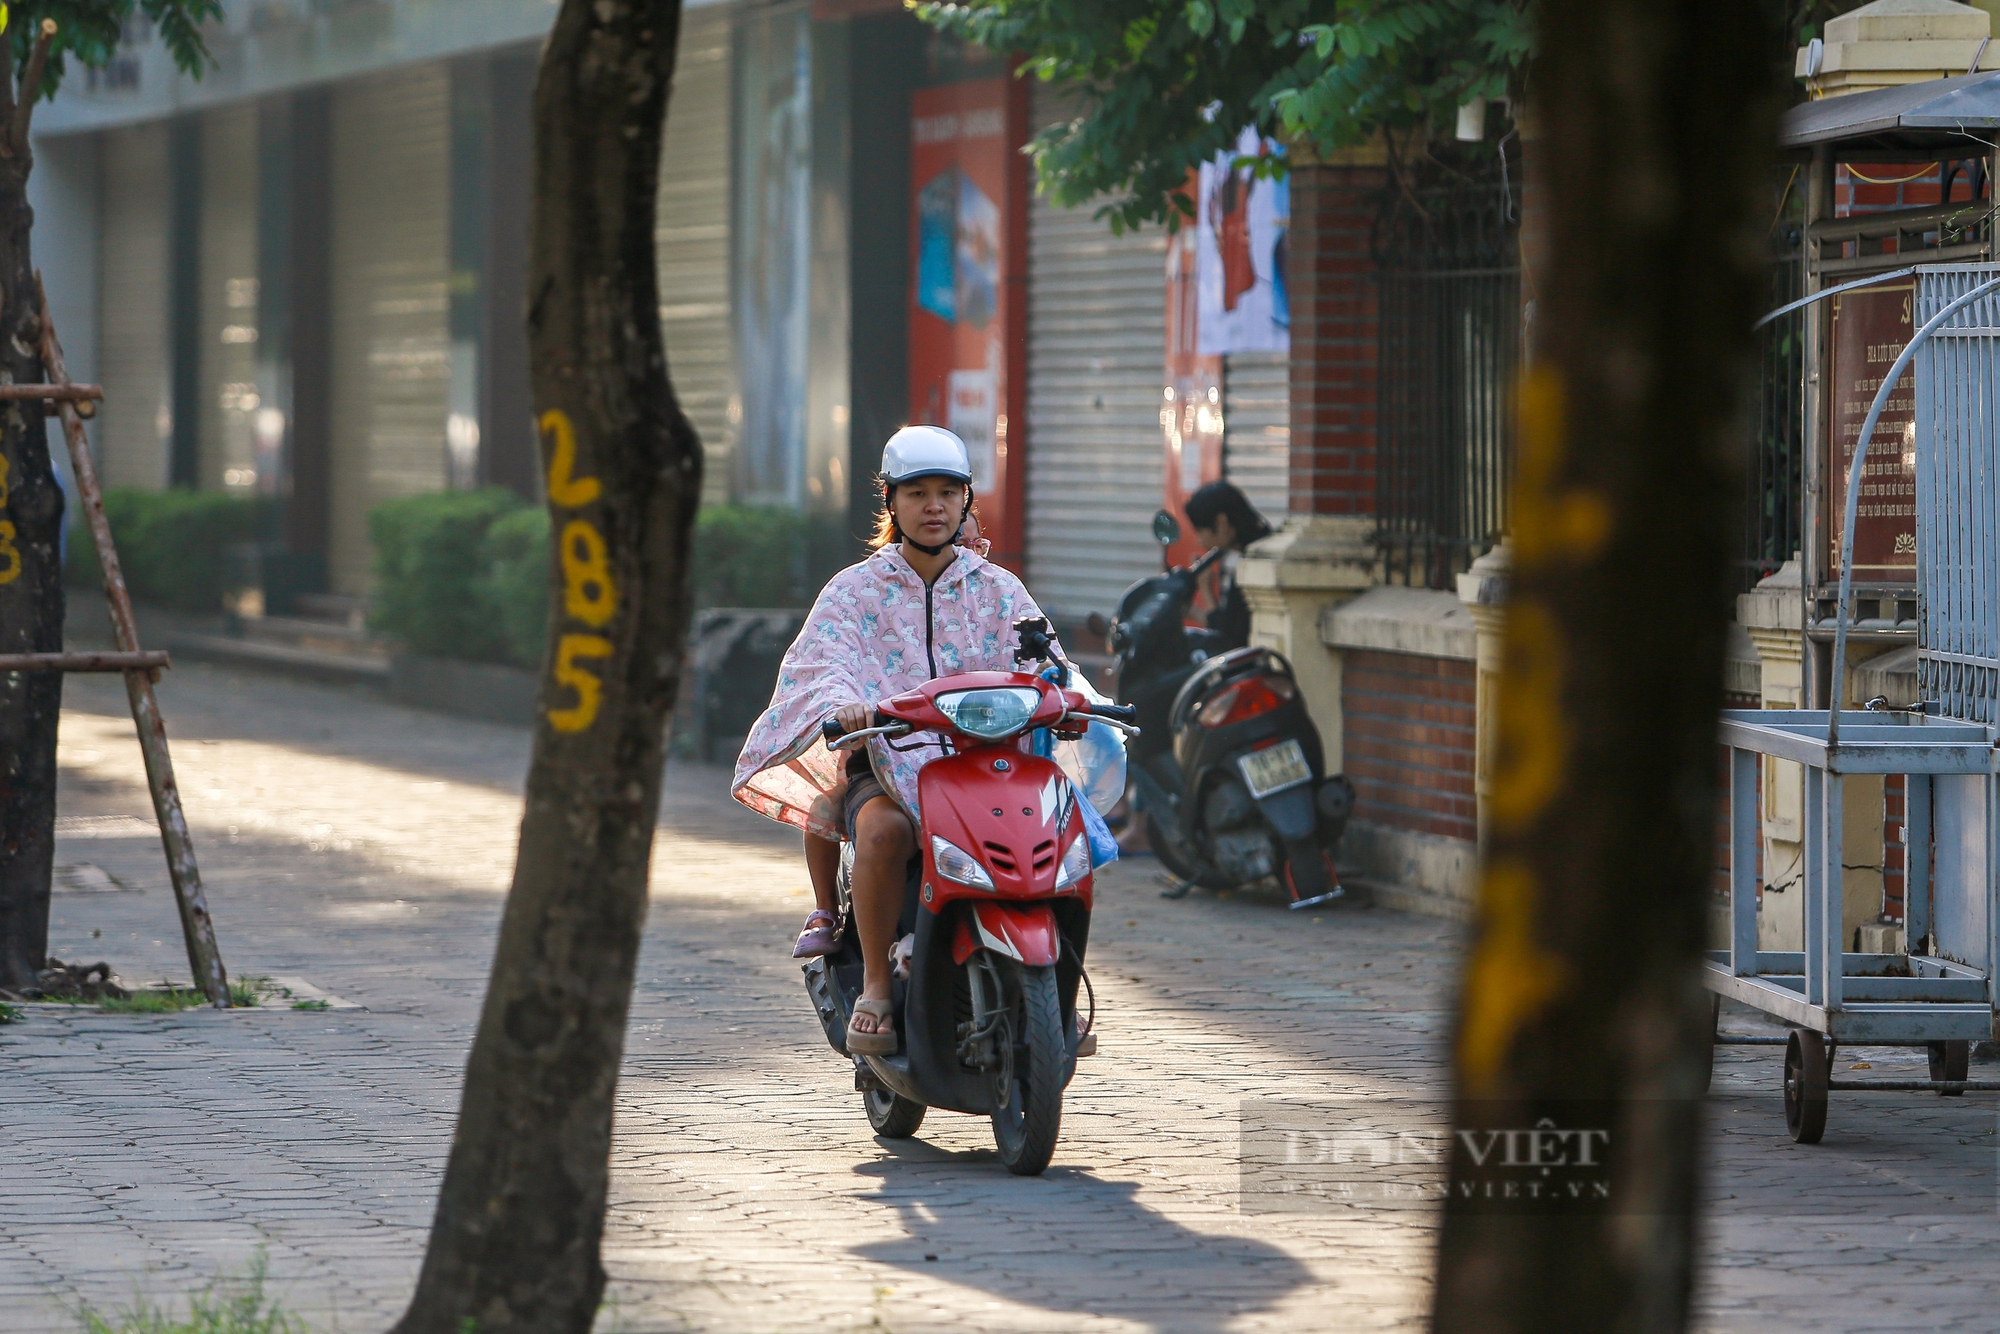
1340;648;1478;842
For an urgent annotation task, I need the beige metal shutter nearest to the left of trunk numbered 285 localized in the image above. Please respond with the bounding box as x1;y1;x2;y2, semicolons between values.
326;64;452;594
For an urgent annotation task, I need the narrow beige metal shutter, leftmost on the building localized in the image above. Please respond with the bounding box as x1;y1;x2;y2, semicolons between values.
96;122;174;490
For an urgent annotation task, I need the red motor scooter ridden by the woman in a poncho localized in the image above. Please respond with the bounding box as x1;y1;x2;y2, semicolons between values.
804;622;1136;1176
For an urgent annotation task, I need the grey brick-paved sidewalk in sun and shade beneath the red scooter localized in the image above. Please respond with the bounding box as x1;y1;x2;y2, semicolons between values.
0;666;2000;1332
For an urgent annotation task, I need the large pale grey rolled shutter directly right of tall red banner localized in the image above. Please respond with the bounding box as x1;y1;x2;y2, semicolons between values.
1026;86;1166;618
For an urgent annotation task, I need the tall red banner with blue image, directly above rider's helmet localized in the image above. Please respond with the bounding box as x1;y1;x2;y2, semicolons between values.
910;78;1026;570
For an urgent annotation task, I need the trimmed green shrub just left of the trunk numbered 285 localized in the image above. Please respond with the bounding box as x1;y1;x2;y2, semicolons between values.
368;486;524;662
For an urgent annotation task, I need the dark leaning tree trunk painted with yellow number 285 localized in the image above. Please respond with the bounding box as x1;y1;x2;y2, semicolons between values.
396;0;702;1334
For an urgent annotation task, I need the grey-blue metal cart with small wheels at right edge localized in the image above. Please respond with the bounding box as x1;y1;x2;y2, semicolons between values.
1706;256;2000;1144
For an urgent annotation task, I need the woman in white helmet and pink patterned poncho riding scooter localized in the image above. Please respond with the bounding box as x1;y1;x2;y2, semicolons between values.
730;426;1060;1056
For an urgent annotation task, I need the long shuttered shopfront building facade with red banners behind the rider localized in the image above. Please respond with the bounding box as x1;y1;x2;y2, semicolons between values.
34;0;1288;620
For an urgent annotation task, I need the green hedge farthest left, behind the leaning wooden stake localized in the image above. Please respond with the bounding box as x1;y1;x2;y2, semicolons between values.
68;486;270;612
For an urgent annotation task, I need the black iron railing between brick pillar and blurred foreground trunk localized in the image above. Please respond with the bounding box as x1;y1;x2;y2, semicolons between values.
1374;182;1522;588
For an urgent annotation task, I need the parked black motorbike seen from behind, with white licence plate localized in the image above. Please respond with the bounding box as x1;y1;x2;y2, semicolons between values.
1104;510;1354;908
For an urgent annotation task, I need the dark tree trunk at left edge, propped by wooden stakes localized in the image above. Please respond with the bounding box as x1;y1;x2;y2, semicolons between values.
0;78;64;990
